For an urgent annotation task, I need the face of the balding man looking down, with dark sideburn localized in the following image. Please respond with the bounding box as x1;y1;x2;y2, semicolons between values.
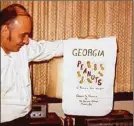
2;16;32;53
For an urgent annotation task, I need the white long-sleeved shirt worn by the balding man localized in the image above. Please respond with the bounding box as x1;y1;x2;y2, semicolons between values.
1;39;63;122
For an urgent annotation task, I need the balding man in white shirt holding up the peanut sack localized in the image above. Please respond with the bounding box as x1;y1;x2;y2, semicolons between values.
0;4;98;126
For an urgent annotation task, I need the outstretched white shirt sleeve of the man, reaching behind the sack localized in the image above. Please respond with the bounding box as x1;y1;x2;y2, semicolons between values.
27;39;64;62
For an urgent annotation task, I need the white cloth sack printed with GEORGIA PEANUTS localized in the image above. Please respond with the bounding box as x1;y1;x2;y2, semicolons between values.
62;37;117;116
